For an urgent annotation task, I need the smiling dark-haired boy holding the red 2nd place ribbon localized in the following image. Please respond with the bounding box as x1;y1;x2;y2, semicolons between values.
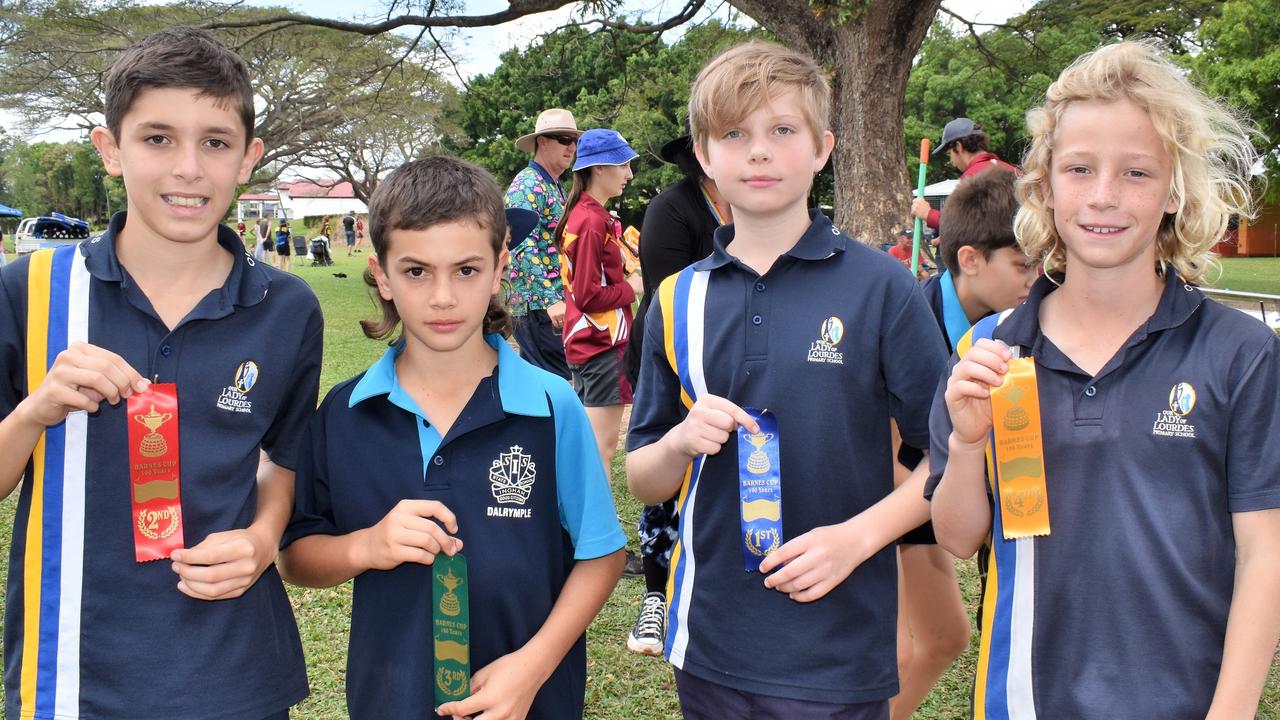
0;28;323;720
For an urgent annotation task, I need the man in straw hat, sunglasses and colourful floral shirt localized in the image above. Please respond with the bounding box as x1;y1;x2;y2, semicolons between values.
507;108;582;380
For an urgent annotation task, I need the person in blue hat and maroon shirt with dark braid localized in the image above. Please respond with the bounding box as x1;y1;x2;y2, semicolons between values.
556;128;644;470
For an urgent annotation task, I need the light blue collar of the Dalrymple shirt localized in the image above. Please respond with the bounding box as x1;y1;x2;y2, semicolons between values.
347;333;552;418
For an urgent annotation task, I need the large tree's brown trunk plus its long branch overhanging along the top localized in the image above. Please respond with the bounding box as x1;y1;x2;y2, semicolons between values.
210;0;941;242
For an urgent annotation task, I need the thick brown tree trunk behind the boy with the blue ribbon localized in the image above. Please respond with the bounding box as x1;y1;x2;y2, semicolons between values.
731;0;942;245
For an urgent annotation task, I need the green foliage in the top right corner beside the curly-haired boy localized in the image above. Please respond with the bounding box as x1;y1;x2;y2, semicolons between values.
1190;0;1280;202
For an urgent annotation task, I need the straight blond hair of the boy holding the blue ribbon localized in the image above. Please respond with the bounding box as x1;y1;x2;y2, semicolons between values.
689;40;831;152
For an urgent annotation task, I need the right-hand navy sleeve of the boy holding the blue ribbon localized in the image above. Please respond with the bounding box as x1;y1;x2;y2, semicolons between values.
879;278;947;450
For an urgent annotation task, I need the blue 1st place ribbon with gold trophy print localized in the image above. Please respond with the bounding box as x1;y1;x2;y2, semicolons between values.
737;407;782;573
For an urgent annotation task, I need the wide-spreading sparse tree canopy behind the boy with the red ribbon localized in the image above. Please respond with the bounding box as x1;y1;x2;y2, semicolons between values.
0;0;452;190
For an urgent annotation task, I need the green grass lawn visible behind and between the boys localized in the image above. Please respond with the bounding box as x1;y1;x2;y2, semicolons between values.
0;247;1280;720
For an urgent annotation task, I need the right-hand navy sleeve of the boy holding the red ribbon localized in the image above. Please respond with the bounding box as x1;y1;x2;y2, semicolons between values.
262;291;324;470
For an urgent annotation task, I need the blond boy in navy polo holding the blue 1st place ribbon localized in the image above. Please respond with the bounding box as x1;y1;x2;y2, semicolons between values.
627;42;945;719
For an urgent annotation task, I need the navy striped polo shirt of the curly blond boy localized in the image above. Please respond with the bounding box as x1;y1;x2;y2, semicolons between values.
927;272;1280;720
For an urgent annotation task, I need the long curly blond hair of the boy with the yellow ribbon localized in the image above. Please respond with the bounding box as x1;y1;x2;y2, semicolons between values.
1014;41;1257;283
